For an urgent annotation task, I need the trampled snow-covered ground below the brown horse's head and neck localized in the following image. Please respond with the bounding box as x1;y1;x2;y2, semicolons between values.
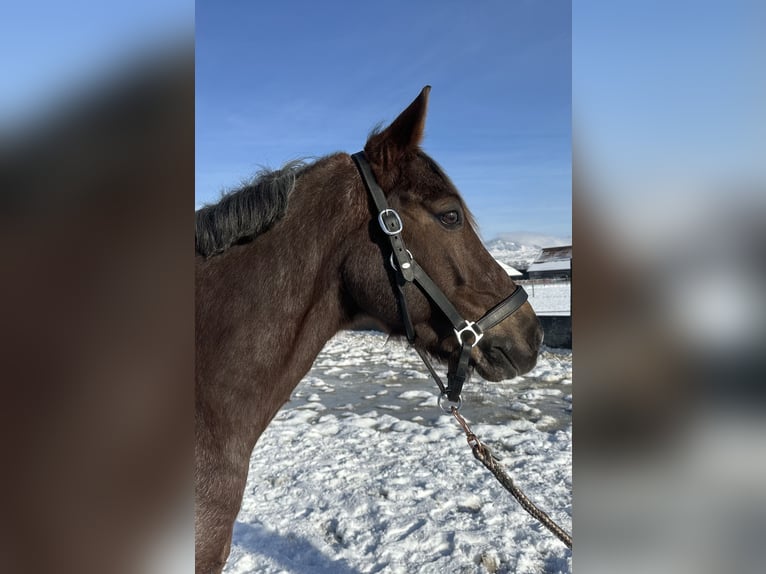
225;332;572;574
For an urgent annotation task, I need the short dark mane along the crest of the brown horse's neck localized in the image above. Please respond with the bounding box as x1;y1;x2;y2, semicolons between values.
194;160;307;257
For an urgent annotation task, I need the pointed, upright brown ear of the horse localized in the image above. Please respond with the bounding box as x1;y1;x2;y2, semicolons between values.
364;86;431;167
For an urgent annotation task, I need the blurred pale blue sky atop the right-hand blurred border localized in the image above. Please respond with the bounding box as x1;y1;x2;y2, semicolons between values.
572;0;766;189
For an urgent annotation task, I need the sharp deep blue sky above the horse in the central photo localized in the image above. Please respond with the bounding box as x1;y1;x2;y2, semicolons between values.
195;0;571;243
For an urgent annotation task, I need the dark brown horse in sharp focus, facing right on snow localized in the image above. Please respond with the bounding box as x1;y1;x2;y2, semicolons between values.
195;86;542;574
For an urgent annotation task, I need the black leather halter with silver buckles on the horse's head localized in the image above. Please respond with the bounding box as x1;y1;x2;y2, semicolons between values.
351;151;527;403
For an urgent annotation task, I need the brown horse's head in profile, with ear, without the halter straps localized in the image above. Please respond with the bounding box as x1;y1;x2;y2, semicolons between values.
343;86;542;388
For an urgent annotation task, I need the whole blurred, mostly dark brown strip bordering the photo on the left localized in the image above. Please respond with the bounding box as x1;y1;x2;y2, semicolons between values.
0;2;194;573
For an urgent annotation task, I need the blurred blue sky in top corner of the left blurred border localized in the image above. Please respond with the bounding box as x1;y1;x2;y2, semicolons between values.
0;0;194;126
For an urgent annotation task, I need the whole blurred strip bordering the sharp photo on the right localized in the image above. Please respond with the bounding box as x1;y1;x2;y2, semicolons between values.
573;1;766;573
